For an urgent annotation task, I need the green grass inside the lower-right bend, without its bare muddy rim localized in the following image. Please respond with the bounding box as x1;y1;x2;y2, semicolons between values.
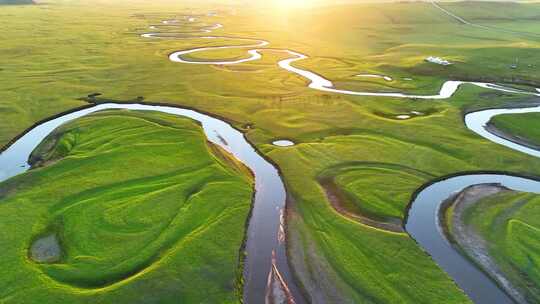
456;192;540;303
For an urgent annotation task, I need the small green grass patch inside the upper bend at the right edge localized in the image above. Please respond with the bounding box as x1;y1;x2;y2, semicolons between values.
490;113;540;146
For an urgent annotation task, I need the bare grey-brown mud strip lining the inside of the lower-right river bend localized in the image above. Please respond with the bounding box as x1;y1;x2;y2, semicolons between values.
439;184;527;304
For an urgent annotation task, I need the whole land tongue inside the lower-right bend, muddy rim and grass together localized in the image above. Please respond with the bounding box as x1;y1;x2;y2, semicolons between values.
441;184;540;303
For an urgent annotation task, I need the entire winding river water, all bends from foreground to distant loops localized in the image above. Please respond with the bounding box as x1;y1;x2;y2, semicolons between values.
0;13;540;303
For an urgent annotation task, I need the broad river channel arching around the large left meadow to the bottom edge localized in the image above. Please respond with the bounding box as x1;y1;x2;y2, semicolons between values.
0;103;302;303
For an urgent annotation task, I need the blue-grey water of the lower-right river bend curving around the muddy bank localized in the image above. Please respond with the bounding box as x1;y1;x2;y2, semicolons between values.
404;170;540;303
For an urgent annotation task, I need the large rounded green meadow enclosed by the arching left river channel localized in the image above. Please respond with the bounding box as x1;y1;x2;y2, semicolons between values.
0;111;252;303
